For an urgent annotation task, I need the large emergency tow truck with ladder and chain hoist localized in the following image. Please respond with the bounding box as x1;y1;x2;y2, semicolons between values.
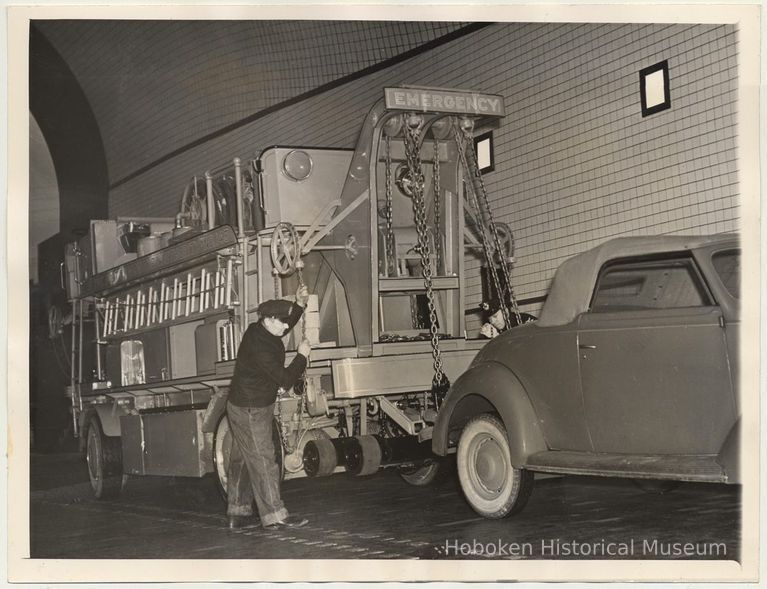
60;87;518;498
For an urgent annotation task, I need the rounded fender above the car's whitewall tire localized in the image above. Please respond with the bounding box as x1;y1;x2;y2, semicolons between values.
432;362;548;467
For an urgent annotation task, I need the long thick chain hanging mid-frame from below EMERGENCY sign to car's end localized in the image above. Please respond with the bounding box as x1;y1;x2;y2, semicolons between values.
405;117;446;387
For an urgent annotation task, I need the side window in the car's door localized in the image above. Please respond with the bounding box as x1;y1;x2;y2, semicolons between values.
591;258;711;312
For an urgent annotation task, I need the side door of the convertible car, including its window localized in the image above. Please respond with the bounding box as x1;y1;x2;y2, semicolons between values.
578;254;735;454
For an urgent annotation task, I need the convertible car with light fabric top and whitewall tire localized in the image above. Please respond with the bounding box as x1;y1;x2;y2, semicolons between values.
432;234;741;518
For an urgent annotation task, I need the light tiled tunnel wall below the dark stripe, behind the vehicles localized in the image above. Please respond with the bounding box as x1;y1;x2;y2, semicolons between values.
100;23;740;333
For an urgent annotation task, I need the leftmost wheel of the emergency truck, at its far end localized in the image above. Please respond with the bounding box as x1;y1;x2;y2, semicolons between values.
85;415;123;499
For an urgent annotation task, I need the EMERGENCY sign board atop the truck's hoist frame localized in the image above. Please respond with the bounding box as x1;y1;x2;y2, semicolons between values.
384;88;506;117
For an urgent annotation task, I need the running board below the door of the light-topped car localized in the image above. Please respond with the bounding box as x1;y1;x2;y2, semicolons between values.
524;450;727;483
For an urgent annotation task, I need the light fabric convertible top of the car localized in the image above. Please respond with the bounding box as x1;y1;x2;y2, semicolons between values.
538;233;738;327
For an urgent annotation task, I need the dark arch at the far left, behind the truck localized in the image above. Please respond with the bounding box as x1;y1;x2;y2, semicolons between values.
29;23;109;451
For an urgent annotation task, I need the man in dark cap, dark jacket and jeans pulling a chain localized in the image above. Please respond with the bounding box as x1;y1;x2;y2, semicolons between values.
226;286;311;530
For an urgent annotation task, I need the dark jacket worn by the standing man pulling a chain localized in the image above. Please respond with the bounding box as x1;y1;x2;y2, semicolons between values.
229;303;306;407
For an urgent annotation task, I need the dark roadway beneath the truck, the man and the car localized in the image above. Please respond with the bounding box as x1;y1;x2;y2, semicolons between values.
30;454;740;560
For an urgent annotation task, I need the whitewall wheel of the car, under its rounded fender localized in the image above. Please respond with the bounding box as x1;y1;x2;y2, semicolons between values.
457;414;533;519
